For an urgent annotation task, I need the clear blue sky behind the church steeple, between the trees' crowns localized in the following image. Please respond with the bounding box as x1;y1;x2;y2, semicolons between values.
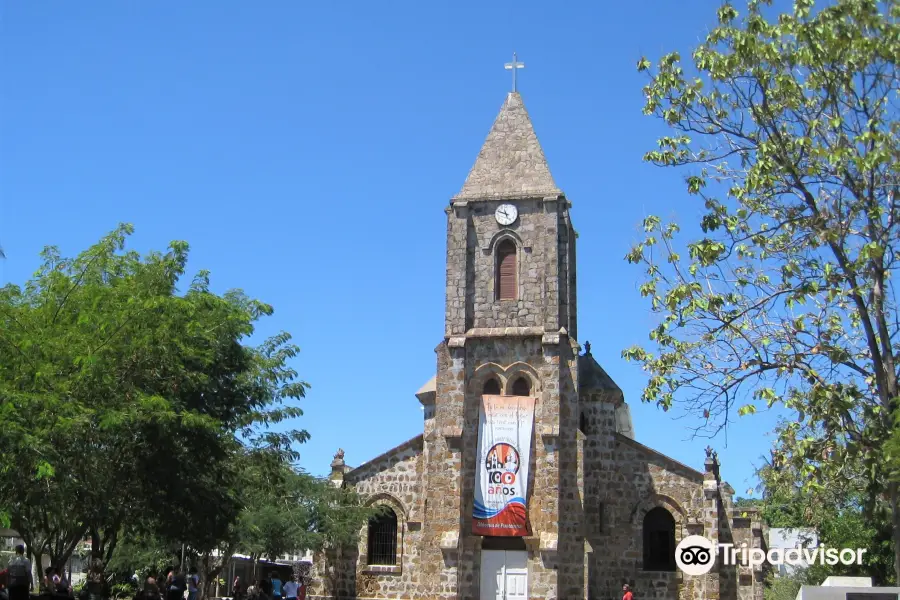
0;0;788;494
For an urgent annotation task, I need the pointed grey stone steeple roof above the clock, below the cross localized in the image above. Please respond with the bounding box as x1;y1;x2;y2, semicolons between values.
454;92;562;200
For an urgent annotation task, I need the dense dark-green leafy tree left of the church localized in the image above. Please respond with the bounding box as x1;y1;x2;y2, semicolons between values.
0;225;308;576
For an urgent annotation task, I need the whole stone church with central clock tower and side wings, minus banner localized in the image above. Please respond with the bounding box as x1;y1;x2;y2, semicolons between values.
310;92;765;600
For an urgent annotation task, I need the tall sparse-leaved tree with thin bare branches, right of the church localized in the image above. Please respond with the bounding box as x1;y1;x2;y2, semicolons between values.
624;0;900;577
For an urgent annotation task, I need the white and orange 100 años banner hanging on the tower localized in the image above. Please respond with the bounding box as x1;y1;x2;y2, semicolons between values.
472;396;535;536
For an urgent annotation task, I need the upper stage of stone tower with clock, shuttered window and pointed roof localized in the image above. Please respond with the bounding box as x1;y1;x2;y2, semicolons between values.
445;92;576;338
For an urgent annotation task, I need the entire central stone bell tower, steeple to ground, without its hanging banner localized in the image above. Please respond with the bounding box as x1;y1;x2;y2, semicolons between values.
424;90;585;598
